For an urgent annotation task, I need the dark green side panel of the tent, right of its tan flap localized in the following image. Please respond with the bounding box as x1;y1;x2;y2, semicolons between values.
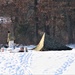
43;34;72;51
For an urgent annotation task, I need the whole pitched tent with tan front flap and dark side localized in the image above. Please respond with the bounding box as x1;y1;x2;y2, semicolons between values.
33;33;72;51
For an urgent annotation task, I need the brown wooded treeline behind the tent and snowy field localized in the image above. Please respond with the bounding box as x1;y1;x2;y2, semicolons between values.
0;0;75;44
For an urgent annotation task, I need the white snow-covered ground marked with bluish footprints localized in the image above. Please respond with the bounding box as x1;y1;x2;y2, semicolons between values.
0;45;75;75
